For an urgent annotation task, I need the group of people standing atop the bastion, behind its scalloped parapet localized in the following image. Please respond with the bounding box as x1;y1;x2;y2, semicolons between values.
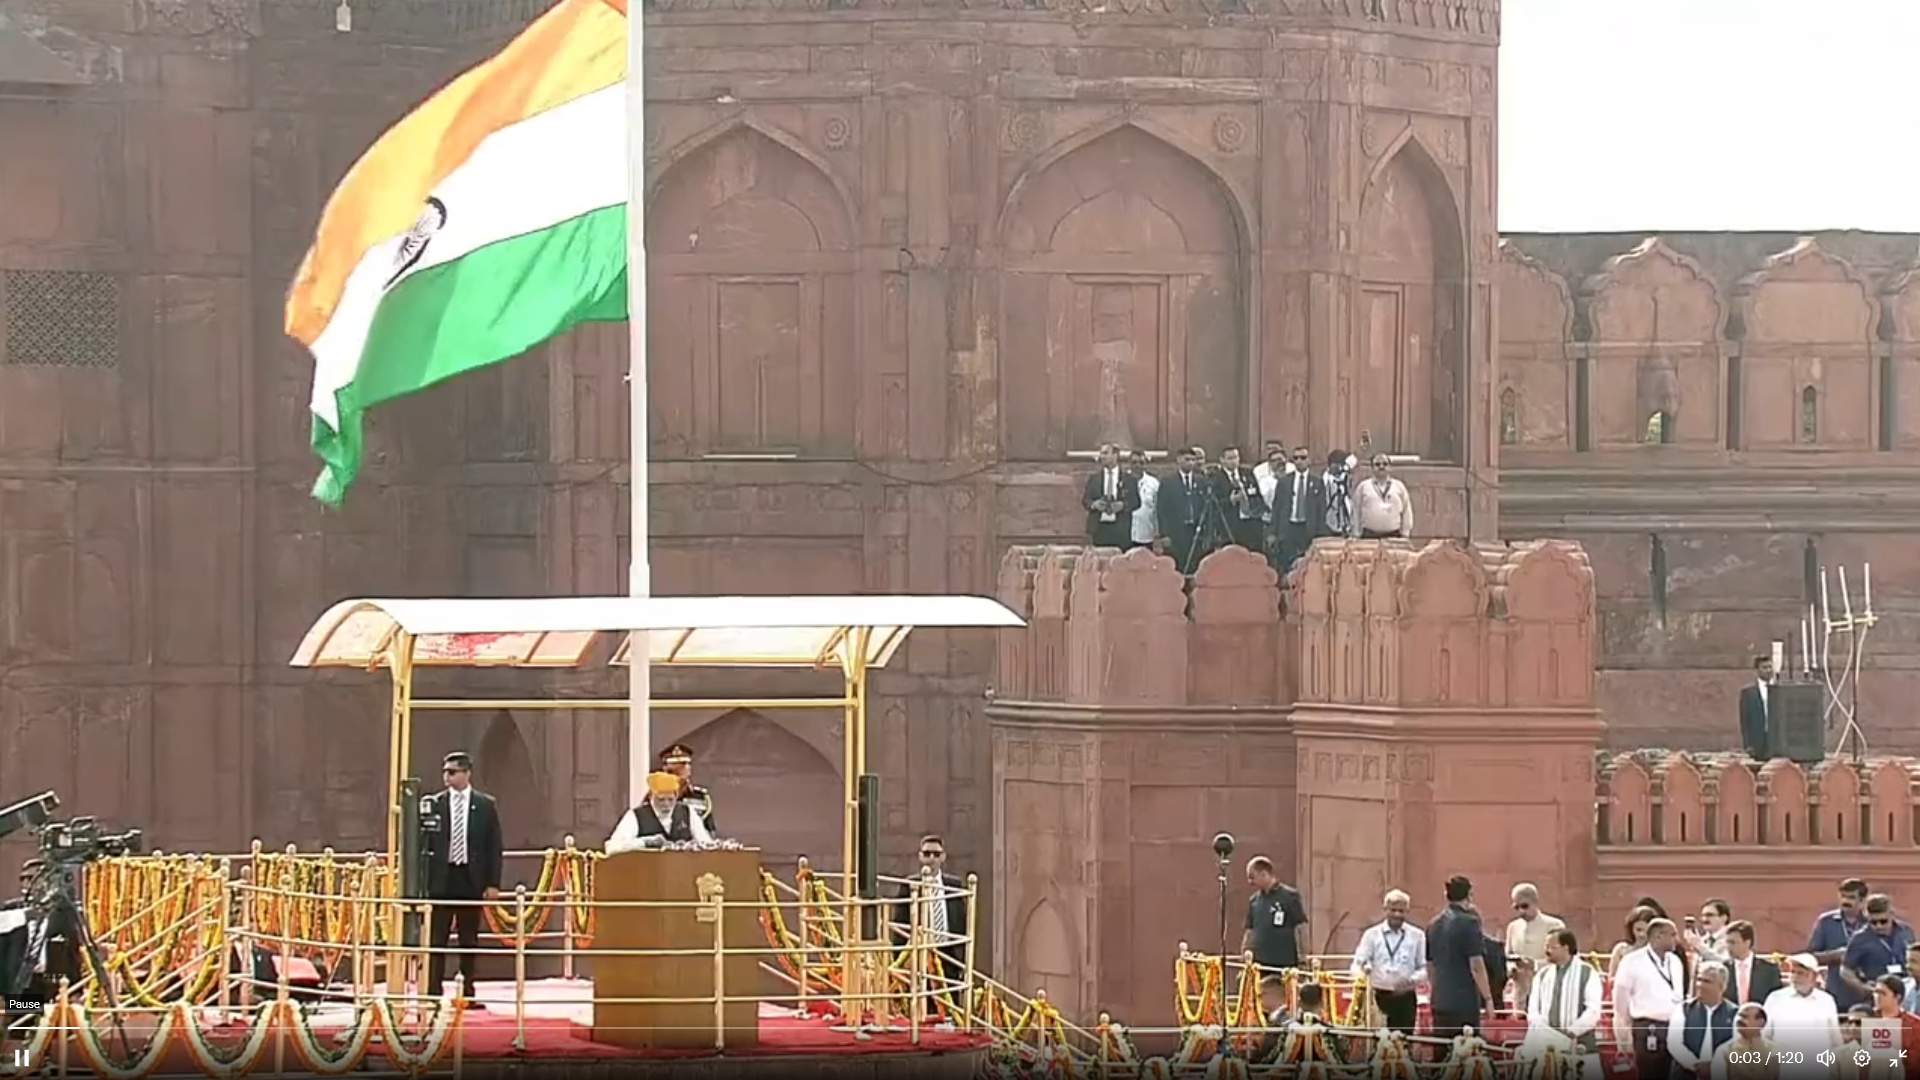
1081;440;1413;575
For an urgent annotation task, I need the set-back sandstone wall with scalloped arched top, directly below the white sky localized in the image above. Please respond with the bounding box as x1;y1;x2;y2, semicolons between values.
1490;233;1920;751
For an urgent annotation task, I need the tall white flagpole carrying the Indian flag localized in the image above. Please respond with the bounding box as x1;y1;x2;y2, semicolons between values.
626;0;653;807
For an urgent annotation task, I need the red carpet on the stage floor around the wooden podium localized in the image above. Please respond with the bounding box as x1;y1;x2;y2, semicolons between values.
332;978;991;1061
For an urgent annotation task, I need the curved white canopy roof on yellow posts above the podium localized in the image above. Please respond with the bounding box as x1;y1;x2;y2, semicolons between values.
290;596;1025;669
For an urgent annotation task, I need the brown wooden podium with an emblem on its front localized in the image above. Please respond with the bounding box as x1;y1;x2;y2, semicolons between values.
593;847;766;1049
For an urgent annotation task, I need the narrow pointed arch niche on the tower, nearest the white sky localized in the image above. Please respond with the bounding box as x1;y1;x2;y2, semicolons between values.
1332;127;1467;461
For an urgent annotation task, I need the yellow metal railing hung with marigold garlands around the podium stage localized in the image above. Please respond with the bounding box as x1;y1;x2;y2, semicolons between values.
7;840;1013;1080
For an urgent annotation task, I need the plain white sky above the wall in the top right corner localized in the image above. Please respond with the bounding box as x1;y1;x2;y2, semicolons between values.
1500;0;1920;233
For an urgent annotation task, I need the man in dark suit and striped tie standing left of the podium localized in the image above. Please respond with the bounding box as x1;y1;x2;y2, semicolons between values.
424;749;505;997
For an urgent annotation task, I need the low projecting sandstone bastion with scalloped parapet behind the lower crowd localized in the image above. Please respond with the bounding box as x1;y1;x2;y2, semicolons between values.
989;540;1920;1022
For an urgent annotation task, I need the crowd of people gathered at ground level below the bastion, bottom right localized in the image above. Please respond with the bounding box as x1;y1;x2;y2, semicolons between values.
1242;857;1920;1080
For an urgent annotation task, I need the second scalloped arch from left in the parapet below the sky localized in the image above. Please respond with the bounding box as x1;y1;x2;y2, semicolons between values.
1580;236;1728;448
